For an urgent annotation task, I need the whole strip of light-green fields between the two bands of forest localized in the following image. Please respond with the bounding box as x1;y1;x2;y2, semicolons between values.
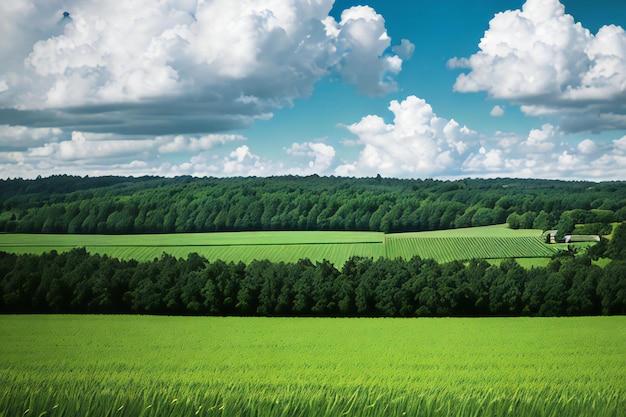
0;225;556;265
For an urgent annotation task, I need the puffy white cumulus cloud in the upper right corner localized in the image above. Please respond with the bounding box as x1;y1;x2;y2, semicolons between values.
448;0;626;131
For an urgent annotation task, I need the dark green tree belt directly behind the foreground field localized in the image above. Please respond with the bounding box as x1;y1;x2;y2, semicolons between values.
0;222;626;317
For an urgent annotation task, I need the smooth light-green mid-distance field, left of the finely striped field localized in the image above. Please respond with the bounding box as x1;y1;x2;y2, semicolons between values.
0;232;385;265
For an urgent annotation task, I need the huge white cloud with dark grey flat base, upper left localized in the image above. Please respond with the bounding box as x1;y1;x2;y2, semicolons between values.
0;0;408;134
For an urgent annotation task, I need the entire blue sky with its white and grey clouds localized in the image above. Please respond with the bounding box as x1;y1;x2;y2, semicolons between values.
0;0;626;181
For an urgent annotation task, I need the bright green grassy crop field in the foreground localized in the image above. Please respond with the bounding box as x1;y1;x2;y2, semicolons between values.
0;315;626;417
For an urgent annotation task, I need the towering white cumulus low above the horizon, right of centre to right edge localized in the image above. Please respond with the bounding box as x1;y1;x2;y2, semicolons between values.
334;96;626;180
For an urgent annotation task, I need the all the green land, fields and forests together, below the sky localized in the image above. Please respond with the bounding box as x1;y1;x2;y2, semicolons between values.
0;177;626;416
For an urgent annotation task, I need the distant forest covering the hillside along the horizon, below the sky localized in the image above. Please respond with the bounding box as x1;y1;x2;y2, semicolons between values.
0;176;626;234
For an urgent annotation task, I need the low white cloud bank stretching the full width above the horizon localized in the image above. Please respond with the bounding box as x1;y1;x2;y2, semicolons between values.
0;96;626;180
